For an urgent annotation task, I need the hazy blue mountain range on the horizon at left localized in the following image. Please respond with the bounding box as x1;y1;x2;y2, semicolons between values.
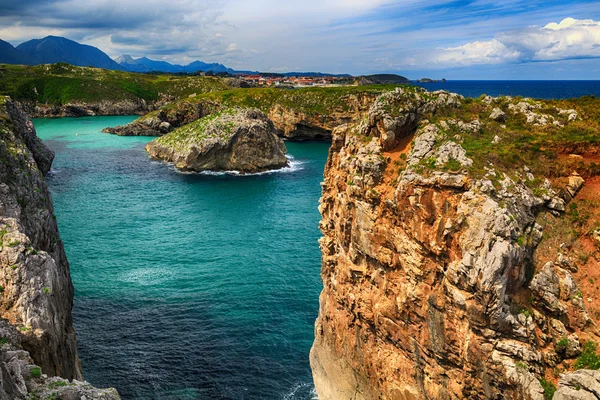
0;36;235;73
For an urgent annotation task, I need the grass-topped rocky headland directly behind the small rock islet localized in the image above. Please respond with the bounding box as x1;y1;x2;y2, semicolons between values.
104;87;383;141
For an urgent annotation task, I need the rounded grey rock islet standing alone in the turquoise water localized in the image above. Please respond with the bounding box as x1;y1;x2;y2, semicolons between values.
146;108;289;173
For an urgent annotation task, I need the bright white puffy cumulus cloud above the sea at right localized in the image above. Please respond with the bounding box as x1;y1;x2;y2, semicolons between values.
431;18;600;66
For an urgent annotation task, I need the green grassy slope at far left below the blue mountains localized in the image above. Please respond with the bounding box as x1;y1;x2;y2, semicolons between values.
0;63;229;105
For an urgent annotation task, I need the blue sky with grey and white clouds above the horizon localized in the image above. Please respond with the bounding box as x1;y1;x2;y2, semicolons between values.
0;0;600;79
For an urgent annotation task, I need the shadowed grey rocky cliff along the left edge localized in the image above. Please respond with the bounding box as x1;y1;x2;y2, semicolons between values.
0;97;116;398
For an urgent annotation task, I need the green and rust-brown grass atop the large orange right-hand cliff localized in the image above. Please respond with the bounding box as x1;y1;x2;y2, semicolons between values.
430;96;600;180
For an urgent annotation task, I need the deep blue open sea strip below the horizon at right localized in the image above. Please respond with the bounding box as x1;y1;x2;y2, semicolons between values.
414;81;600;99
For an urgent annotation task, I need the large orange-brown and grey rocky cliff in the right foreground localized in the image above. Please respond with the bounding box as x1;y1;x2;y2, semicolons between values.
311;88;600;400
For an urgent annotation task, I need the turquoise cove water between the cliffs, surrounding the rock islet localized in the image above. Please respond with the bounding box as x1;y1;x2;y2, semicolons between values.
34;117;328;399
